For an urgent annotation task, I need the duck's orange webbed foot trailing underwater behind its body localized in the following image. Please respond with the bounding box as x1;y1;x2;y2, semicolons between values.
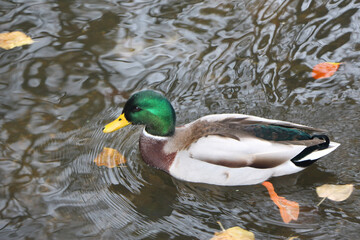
262;181;300;223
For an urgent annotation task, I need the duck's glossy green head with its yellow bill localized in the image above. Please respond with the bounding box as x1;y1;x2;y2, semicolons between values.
103;90;176;136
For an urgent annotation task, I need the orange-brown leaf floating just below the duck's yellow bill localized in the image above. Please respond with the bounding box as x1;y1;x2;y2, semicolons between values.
94;147;126;168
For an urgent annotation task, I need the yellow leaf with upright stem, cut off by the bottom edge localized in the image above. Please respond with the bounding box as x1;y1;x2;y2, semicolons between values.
210;222;255;240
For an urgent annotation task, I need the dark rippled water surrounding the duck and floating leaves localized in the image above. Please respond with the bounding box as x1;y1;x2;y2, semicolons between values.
0;0;360;240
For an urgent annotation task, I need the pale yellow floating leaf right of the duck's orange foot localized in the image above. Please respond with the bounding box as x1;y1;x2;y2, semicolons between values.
316;184;354;206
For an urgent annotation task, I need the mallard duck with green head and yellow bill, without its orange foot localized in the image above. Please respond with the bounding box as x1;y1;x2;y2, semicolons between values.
103;90;340;186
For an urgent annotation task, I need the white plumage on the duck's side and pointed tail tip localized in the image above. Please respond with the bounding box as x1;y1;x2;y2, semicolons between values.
169;136;340;186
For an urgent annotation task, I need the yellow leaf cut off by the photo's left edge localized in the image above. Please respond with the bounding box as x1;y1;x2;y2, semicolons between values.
0;31;34;50
